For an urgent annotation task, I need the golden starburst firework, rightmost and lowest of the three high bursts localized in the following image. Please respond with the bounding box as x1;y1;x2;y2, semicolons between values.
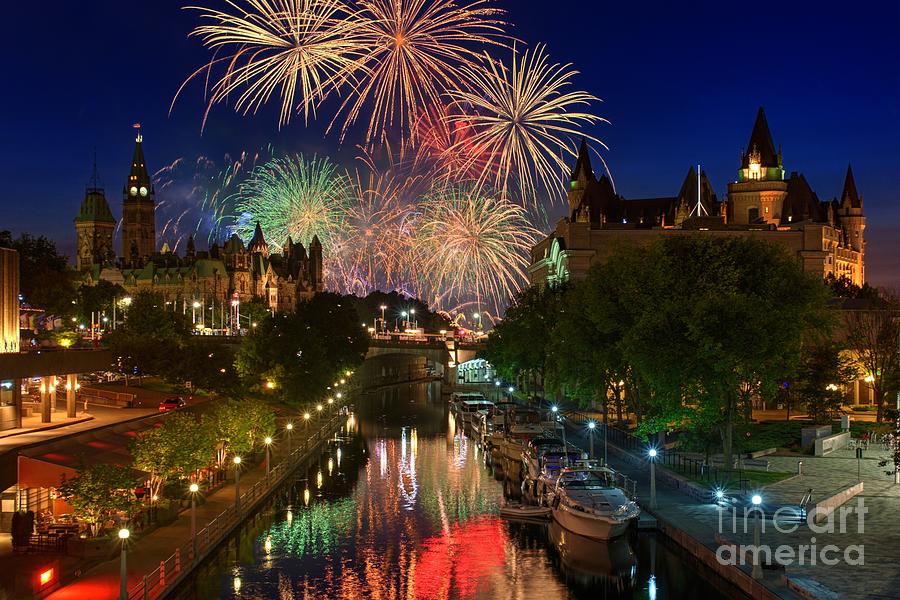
447;46;605;206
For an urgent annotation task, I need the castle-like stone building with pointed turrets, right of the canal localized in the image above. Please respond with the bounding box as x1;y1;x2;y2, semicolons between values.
529;108;866;285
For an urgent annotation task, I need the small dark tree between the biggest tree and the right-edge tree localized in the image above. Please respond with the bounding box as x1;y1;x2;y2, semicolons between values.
794;340;858;423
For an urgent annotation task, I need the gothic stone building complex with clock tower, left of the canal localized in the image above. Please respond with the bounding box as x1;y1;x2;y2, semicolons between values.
75;129;323;321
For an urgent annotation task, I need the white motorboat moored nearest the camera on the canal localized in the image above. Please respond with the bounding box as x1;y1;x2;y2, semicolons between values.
550;465;641;540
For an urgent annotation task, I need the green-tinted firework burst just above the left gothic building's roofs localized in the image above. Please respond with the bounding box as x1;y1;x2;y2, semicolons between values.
235;155;353;256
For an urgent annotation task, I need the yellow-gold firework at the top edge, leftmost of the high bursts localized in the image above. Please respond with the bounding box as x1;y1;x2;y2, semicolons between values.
178;0;366;127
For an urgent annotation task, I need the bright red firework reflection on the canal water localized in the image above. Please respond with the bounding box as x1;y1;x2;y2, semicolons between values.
413;516;507;598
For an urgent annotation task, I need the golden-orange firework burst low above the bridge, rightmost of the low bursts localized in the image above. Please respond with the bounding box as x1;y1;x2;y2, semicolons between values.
410;185;540;312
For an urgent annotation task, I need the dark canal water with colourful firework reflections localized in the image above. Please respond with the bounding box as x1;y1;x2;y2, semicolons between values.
176;386;744;600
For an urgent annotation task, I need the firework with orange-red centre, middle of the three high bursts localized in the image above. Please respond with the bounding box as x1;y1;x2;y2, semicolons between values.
331;0;506;145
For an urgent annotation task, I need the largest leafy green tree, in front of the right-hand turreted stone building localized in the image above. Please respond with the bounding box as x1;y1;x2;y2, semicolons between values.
620;236;831;469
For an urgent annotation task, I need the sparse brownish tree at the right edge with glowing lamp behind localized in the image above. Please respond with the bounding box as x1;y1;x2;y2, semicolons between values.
844;293;900;421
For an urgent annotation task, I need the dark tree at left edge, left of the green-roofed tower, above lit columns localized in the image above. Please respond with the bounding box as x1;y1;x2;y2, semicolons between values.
0;231;75;317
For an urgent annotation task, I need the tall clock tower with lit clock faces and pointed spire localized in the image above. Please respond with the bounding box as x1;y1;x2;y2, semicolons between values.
122;123;156;265
